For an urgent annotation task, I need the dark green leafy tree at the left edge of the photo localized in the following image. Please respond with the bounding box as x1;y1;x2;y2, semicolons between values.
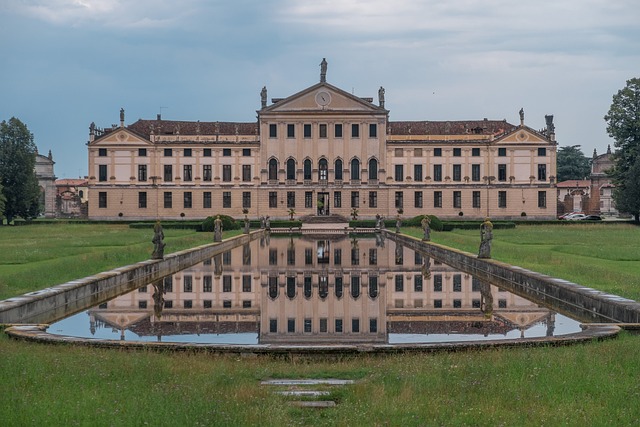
0;117;40;224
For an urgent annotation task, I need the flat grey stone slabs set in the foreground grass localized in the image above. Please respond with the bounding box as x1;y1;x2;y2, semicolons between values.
260;379;354;409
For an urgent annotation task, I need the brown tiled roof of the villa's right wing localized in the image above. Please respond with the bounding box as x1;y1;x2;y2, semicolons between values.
389;120;516;135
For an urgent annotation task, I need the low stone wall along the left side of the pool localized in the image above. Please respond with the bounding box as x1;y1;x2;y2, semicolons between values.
0;230;264;324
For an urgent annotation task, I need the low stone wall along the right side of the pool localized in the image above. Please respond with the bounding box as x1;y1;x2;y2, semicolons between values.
382;230;640;323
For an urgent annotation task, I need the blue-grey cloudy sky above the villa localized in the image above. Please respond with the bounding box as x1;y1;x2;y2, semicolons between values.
0;0;640;178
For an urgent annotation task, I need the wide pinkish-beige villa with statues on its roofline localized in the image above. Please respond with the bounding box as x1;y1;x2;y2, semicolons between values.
87;60;558;220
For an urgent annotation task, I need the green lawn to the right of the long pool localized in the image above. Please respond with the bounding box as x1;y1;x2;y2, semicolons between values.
404;224;640;301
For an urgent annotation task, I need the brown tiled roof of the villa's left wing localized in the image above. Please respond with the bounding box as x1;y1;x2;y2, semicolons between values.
127;119;258;137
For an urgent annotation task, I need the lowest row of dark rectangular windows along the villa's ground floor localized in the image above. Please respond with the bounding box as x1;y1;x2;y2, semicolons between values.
98;190;547;209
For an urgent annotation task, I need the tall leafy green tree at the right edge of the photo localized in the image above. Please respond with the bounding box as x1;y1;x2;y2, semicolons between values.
604;78;640;221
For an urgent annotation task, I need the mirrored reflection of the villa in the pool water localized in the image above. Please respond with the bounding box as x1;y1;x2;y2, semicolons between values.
90;238;554;344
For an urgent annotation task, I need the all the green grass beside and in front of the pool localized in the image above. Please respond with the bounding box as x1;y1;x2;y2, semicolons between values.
0;225;640;426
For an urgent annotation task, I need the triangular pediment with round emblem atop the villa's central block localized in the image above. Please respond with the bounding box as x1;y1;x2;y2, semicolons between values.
260;82;387;114
